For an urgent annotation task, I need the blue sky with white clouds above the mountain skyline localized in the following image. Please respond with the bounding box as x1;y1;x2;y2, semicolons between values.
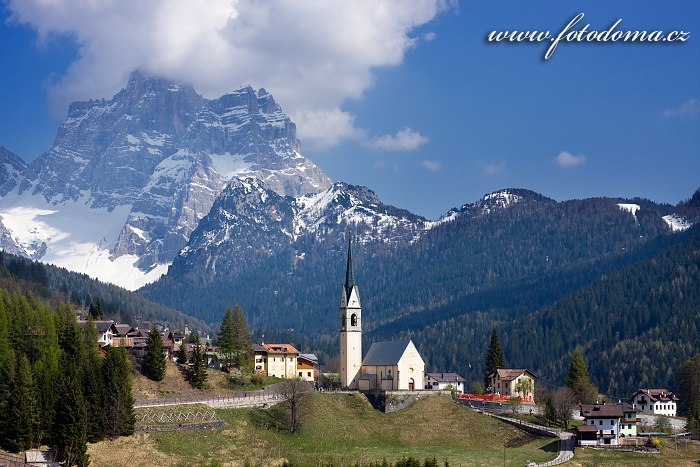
0;0;700;218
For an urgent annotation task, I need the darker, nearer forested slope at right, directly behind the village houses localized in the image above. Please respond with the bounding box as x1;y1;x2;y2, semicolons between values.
380;228;700;397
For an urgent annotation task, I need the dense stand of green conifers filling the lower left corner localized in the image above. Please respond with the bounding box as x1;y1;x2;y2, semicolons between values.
0;288;135;466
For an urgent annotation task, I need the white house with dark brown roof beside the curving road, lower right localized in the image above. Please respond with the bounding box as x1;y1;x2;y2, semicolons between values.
576;404;623;446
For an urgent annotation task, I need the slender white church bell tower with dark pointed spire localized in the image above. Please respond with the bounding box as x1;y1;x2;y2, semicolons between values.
340;240;362;389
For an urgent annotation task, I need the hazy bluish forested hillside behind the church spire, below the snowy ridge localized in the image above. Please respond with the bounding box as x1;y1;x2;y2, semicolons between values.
141;189;697;337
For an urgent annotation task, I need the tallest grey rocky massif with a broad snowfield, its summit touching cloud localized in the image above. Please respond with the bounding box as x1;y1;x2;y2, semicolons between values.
0;72;330;289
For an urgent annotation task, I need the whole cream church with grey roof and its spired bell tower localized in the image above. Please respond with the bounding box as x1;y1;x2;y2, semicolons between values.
340;241;425;391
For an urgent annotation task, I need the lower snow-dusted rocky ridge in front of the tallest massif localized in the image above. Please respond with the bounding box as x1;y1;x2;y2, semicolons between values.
169;178;430;279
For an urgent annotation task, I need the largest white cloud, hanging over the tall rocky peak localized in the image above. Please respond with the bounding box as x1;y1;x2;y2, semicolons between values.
7;0;448;146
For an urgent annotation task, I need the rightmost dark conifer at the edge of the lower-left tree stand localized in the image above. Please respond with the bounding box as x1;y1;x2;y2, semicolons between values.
102;347;136;439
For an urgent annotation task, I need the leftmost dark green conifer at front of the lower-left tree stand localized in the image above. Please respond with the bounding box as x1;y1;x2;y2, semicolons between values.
5;354;39;452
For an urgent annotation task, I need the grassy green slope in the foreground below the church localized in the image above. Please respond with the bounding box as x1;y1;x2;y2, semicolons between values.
89;394;557;467
